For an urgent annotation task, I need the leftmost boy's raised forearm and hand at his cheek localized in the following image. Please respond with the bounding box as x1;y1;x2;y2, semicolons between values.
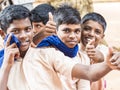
0;35;19;90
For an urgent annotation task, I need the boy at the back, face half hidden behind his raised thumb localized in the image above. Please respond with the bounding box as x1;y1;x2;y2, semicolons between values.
31;4;56;45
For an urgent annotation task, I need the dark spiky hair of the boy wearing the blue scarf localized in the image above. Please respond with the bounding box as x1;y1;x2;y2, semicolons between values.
54;4;81;27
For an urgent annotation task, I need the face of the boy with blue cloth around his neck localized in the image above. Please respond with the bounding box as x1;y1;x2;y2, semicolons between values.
57;24;81;48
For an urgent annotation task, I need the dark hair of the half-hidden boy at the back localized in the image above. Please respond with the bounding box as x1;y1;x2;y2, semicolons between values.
31;4;55;24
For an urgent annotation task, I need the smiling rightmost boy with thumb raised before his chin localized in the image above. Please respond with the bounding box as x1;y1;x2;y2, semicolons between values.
81;12;108;90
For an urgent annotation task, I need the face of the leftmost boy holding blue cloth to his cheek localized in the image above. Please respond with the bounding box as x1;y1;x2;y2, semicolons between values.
7;18;33;51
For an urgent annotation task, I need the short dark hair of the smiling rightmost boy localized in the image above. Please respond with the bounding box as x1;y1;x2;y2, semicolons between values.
81;12;107;31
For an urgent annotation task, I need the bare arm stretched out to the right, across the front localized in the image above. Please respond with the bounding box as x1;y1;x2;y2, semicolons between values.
72;49;114;81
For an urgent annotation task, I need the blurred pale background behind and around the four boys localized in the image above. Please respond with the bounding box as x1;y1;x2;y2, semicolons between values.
0;0;120;90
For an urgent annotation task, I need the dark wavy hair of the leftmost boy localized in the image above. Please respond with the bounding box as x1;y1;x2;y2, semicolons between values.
0;5;30;32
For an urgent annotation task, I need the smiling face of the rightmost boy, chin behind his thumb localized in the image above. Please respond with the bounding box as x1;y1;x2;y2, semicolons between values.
81;20;104;47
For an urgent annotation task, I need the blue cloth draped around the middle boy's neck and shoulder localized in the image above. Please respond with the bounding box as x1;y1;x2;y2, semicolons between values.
37;35;78;57
